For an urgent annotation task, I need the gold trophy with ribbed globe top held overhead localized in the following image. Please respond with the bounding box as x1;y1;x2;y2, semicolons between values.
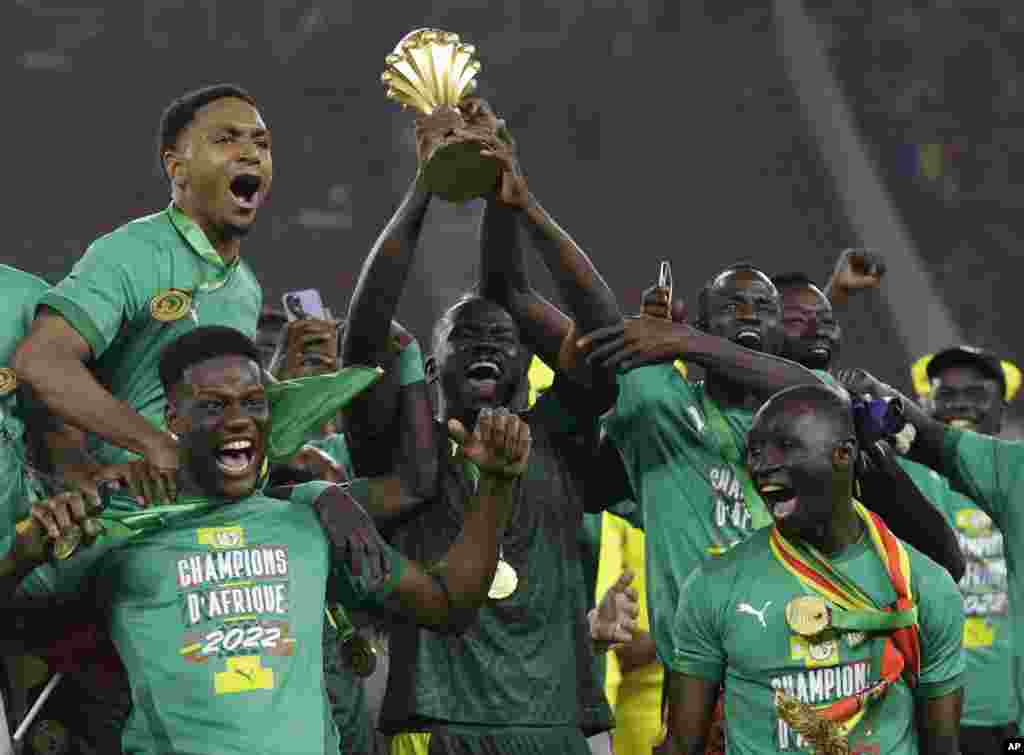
381;29;501;202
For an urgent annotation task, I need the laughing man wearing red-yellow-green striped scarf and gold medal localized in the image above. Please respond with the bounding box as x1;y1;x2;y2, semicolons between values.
667;386;964;755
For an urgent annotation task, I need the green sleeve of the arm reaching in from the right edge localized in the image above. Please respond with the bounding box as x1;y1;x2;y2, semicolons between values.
943;427;1024;528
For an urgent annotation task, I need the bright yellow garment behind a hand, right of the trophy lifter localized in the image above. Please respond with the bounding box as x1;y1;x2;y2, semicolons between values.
597;511;665;755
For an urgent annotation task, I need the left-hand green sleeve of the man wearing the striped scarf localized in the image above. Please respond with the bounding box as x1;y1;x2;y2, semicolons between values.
658;569;726;682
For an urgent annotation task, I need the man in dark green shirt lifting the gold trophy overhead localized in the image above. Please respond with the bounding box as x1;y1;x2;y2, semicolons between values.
344;98;634;755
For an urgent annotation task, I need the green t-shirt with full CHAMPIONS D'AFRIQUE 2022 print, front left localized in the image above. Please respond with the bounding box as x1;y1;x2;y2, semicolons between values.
23;483;404;755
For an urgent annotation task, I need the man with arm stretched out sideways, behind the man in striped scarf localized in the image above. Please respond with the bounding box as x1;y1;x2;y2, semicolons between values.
580;264;819;675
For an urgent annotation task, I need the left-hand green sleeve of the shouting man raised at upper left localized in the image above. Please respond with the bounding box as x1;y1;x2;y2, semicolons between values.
40;230;154;359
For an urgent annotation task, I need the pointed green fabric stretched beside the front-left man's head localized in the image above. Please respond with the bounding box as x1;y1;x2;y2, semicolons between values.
266;367;384;464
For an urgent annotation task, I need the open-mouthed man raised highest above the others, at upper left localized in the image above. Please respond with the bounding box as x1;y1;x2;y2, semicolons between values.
13;85;273;503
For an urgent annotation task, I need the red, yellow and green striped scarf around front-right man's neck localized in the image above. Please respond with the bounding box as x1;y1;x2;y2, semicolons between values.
770;500;921;733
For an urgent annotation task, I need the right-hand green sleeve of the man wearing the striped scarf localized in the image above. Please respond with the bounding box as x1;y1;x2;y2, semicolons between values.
912;554;966;698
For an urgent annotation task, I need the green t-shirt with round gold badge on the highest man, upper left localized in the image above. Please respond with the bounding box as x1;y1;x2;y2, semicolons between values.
40;205;263;463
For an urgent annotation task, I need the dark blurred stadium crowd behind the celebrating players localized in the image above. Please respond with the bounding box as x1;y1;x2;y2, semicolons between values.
9;0;1024;424
